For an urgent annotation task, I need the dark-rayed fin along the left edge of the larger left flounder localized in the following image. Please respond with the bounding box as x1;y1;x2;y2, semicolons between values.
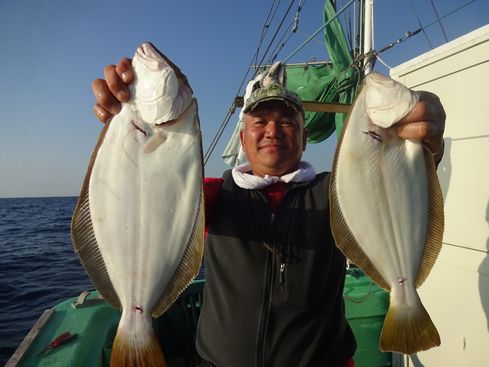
71;122;121;308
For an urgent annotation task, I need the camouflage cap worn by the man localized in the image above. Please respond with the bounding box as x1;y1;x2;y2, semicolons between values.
243;62;304;117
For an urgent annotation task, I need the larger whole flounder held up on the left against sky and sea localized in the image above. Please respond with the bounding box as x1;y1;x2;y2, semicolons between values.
72;43;204;366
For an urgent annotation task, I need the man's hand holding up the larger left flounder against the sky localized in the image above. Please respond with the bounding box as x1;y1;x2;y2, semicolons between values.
92;58;134;123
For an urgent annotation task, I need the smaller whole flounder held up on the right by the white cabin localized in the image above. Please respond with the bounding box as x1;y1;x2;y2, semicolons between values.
330;73;444;354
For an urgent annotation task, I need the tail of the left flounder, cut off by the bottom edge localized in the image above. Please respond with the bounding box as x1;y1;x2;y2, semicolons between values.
110;312;167;367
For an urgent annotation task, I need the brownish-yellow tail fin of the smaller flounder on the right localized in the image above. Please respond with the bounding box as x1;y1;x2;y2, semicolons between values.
380;292;441;354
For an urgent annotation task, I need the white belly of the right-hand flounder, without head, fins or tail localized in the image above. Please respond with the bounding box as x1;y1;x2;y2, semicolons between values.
336;92;427;285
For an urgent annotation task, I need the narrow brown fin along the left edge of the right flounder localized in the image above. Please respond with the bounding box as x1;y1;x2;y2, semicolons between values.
329;157;390;290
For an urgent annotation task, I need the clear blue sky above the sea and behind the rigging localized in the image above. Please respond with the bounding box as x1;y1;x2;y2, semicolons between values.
0;0;489;198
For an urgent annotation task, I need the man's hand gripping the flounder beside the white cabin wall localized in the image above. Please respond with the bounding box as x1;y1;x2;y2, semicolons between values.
397;91;446;164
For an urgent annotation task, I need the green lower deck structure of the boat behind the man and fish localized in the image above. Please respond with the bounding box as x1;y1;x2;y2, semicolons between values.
12;269;391;367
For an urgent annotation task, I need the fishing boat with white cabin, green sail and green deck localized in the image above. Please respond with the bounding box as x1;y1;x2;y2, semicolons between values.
6;1;489;367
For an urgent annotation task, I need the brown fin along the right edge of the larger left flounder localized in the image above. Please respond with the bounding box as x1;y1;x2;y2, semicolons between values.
151;188;205;317
